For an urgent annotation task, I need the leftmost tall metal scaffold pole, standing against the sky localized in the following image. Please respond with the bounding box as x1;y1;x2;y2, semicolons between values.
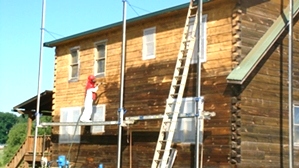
32;0;46;168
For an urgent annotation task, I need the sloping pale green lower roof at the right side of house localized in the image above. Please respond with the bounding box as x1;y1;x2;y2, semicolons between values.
226;0;299;84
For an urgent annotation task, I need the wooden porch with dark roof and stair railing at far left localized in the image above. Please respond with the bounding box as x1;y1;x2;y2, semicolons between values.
6;90;53;168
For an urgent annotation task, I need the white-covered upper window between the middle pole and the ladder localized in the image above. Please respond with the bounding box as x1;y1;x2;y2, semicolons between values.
142;27;156;60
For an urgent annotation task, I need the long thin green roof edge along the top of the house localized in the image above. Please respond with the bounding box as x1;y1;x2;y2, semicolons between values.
44;0;210;47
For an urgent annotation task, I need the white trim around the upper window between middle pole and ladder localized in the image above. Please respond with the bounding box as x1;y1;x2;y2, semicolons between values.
142;27;156;60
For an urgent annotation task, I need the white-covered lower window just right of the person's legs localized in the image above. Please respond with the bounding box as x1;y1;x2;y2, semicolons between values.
90;104;106;134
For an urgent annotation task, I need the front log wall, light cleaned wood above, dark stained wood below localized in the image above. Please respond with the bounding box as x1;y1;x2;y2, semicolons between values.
52;0;236;168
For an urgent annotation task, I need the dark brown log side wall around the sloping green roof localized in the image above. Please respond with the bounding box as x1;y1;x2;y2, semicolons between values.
231;0;299;168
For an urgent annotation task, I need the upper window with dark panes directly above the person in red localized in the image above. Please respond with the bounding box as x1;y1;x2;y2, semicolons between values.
94;40;107;76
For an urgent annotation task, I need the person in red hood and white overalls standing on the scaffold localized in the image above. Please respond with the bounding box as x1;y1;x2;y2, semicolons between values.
80;75;98;122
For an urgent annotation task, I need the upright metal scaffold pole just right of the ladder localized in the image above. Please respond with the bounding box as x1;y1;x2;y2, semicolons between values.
194;0;203;168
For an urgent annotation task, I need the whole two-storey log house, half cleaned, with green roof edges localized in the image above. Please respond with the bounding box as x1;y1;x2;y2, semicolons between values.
7;0;299;168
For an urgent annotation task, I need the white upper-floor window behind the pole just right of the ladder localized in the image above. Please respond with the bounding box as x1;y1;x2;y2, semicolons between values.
191;14;208;64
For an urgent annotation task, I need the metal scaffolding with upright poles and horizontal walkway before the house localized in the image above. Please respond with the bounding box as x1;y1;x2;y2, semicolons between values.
33;0;216;168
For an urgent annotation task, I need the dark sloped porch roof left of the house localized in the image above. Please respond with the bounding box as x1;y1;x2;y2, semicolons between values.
13;90;53;114
